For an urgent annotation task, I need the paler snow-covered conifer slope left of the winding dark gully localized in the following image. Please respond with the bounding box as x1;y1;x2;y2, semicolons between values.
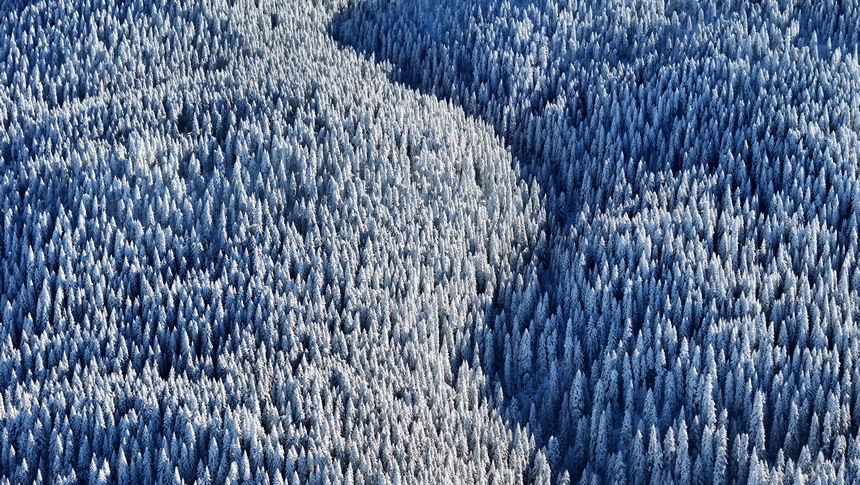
0;2;549;484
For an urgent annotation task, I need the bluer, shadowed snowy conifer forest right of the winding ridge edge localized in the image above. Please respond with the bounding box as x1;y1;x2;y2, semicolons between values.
331;0;860;483
